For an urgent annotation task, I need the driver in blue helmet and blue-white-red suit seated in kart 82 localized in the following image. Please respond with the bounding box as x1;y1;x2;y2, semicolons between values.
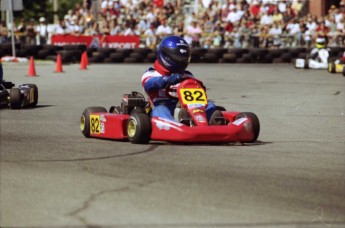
141;36;222;125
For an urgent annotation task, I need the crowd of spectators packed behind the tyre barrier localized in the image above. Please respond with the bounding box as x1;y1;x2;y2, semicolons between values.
0;0;345;48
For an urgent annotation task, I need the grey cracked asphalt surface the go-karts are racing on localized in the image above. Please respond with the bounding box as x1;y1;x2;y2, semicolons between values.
0;63;345;227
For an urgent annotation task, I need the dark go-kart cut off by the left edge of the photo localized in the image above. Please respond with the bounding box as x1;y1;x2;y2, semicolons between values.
0;81;38;109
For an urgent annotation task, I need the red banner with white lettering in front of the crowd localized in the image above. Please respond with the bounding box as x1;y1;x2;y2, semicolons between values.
51;35;140;48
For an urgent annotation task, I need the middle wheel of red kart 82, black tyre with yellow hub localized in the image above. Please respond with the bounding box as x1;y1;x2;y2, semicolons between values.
127;112;152;144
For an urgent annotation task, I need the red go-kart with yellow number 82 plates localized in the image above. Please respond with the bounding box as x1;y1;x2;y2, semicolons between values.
80;78;260;144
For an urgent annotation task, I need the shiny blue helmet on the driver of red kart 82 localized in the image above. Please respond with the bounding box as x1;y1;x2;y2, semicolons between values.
157;36;190;74
